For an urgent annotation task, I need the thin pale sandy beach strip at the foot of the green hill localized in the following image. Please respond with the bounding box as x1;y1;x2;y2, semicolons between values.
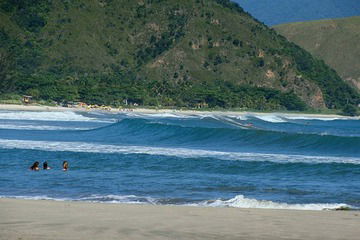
0;104;354;120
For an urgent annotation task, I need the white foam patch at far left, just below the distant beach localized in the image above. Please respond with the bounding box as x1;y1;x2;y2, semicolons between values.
0;111;104;122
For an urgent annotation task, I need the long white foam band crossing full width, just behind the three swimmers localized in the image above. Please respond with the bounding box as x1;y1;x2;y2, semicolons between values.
0;139;360;164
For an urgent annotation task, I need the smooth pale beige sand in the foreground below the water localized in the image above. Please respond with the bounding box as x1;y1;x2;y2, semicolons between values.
0;199;360;240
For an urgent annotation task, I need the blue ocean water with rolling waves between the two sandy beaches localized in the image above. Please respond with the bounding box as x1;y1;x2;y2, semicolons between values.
0;111;360;210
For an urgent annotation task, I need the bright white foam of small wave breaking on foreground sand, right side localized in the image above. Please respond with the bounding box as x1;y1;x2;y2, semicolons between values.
200;195;351;211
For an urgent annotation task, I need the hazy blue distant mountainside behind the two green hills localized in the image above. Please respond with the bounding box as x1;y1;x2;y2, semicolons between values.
234;0;360;26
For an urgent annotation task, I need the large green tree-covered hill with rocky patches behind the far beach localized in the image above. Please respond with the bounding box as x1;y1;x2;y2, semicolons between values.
0;0;359;110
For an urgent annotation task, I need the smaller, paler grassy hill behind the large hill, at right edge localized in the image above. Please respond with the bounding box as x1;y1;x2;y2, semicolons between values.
274;17;360;90
